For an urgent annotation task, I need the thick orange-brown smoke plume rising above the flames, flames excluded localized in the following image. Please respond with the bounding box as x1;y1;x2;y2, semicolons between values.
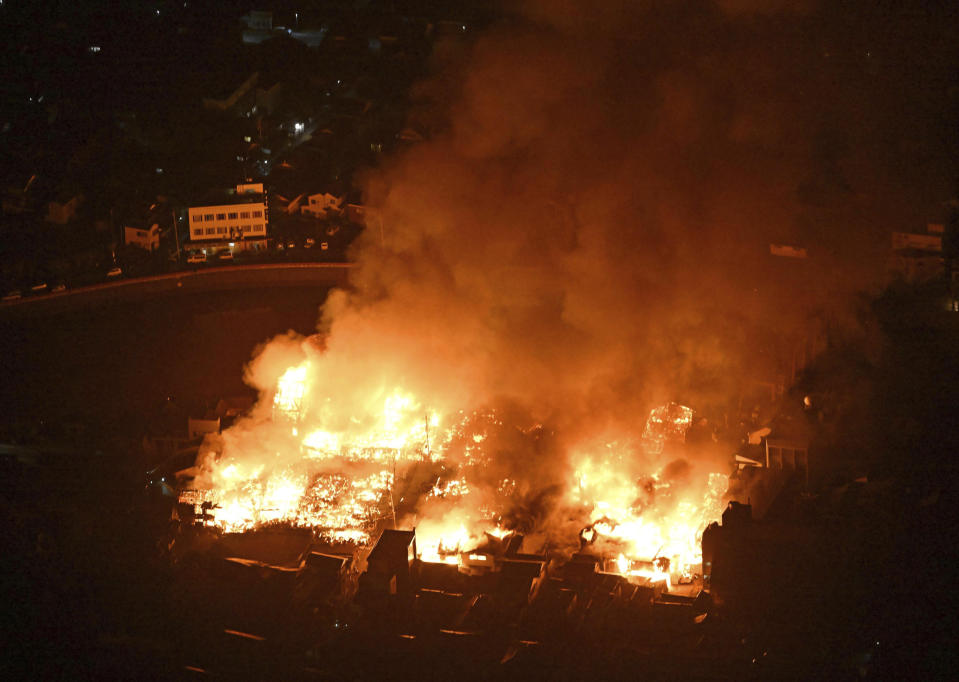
201;0;944;540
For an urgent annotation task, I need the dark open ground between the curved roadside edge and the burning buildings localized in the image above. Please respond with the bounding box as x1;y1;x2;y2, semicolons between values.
0;263;348;433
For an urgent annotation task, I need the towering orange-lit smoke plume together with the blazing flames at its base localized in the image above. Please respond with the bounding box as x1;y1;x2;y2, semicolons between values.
188;0;936;570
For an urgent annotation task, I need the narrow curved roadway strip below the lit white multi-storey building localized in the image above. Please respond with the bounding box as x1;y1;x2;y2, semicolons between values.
0;263;353;314
